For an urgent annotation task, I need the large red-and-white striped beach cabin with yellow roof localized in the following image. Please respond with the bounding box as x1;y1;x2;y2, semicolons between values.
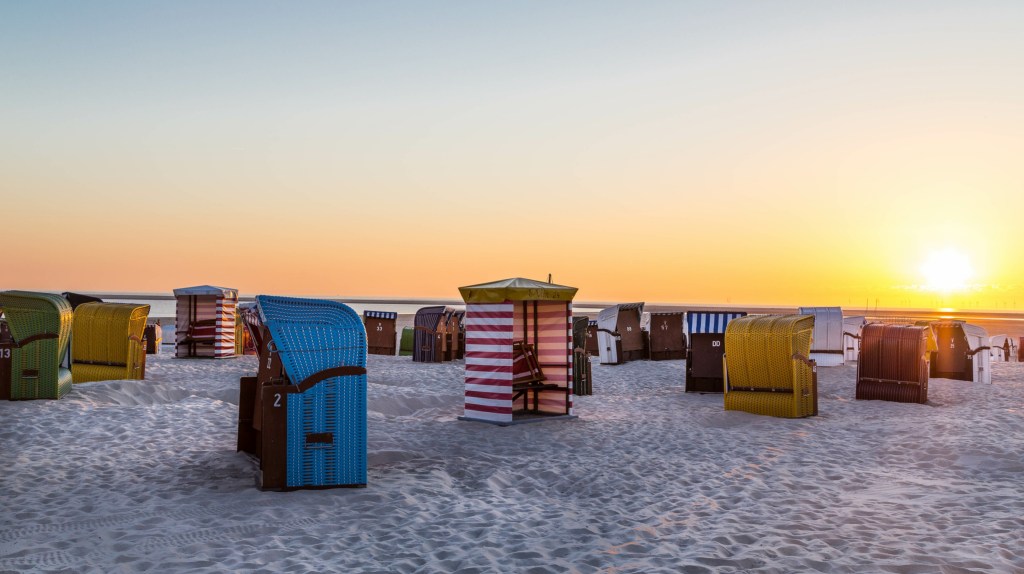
459;277;577;425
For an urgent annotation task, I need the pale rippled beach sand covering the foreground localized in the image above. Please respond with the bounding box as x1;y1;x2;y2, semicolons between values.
0;351;1024;573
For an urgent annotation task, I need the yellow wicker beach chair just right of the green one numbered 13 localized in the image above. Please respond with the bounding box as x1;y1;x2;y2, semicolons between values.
71;303;150;383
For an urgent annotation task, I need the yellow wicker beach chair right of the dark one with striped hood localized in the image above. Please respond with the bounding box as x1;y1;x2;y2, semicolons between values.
723;315;818;418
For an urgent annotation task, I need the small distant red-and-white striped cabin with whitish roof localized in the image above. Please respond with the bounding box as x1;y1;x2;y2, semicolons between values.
174;285;239;359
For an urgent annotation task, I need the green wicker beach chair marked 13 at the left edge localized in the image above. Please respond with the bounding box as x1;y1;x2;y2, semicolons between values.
0;291;74;399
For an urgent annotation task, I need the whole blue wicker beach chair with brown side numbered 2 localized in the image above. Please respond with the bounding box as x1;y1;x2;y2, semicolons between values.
238;296;367;490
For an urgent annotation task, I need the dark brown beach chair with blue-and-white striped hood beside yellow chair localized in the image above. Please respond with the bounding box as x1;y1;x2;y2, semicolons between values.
686;311;746;393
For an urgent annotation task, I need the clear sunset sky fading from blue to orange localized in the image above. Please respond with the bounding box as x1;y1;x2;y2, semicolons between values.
0;0;1024;311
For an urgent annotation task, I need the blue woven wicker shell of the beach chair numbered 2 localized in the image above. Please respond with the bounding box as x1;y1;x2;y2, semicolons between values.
256;296;367;488
